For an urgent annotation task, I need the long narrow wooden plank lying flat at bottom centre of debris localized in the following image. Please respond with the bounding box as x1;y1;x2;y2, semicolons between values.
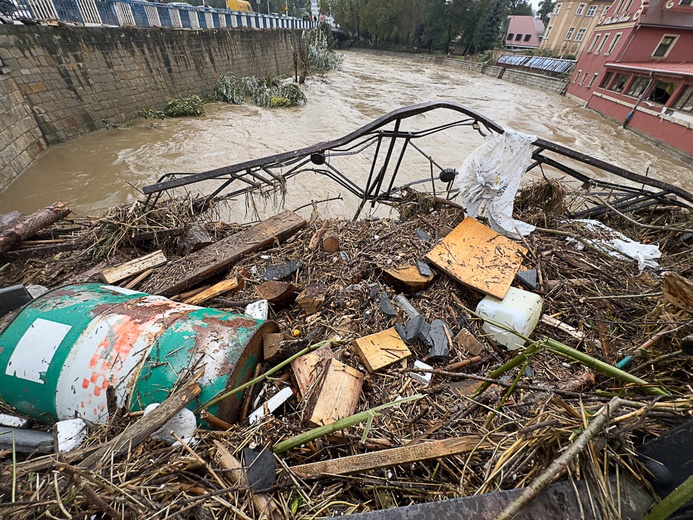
291;435;492;478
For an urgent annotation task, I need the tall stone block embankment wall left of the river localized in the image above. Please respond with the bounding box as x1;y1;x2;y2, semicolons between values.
0;25;300;190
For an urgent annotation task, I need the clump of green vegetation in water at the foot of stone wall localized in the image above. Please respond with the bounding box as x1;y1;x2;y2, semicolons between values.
214;75;306;108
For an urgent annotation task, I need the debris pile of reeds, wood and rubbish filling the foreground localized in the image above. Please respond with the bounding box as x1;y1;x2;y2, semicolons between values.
0;181;693;519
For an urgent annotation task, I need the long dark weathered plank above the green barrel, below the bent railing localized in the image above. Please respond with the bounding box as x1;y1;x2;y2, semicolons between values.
144;211;306;296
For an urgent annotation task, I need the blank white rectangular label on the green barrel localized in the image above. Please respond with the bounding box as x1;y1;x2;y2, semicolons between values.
5;318;72;385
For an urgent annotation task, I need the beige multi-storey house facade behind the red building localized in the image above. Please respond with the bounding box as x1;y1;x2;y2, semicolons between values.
539;0;613;57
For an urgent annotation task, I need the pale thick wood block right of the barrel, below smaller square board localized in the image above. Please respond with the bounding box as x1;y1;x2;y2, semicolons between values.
303;358;364;426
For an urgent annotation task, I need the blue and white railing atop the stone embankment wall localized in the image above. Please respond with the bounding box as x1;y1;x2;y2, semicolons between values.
7;0;312;29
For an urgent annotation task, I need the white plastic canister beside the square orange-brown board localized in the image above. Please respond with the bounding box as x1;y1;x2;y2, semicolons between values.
476;287;543;350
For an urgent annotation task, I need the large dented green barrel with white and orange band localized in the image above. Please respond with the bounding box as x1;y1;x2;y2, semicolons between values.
0;283;277;423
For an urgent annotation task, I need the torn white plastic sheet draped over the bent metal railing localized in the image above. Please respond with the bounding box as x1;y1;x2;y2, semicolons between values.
458;130;536;239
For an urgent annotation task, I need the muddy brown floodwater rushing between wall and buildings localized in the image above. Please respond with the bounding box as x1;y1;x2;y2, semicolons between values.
0;52;693;217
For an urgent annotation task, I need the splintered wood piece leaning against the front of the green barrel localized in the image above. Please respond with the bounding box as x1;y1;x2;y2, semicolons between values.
79;368;205;469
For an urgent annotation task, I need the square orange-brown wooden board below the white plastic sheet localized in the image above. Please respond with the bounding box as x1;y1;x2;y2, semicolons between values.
426;217;527;299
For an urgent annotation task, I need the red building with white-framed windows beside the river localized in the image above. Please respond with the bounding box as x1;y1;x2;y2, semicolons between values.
568;0;693;159
